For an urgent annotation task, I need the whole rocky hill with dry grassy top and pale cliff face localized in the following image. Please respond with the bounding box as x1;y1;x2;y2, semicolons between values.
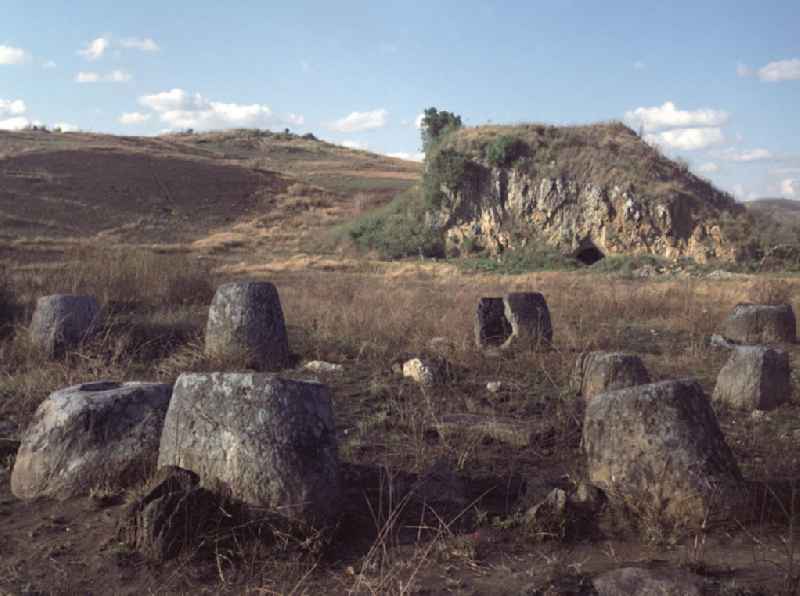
424;123;744;262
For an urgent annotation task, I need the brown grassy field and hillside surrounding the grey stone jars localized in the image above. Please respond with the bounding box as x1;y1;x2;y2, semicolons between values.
0;131;800;596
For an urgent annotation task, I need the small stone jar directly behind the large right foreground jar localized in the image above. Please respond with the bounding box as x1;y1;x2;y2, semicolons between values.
572;352;650;399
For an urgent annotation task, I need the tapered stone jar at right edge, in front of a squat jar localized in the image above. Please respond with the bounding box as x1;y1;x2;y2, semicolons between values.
713;346;792;410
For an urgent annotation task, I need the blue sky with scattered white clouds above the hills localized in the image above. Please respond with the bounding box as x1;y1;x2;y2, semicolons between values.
0;0;800;200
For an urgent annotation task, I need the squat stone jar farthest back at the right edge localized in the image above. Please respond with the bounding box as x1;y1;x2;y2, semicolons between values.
722;304;797;344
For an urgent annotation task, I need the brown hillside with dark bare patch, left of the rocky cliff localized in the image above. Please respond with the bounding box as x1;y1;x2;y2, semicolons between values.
0;130;420;264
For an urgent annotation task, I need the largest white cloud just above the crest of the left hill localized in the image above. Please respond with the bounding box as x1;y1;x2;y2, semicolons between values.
139;89;282;129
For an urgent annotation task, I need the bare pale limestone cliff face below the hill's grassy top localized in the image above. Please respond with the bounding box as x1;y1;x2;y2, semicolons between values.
431;161;737;262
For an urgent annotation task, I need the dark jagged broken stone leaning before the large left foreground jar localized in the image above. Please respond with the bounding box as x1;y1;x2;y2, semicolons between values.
119;466;218;562
